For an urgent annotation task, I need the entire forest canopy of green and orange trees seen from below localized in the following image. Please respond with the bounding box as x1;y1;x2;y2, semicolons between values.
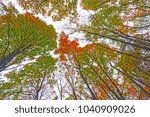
0;0;150;100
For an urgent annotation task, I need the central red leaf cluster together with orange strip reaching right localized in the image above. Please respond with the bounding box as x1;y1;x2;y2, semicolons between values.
54;32;96;61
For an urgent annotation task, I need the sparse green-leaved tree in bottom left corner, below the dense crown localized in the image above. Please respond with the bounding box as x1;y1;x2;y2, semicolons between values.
0;55;56;100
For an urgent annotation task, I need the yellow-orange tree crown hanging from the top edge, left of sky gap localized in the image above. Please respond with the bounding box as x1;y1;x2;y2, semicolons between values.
18;0;77;21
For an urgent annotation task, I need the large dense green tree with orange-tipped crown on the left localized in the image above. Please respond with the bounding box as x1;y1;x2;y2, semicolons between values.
0;2;56;72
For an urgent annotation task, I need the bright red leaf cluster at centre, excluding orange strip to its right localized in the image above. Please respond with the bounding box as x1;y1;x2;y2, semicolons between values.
54;32;81;61
